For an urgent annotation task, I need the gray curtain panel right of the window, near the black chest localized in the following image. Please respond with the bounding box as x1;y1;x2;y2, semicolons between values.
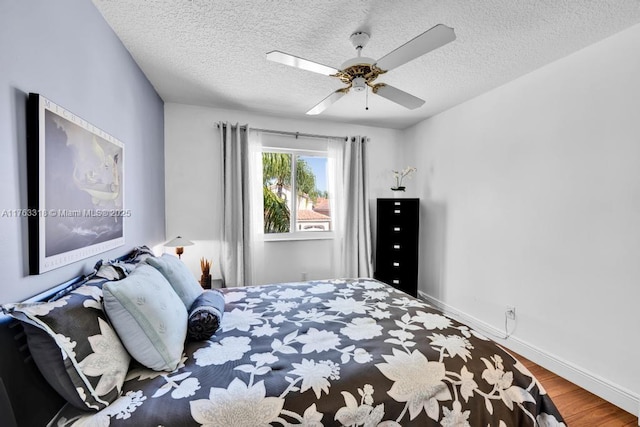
341;136;373;277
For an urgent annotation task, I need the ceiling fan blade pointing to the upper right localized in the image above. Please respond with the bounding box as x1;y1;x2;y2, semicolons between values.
375;24;456;71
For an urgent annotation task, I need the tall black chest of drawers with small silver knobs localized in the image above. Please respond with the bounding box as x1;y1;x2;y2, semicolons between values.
374;199;420;296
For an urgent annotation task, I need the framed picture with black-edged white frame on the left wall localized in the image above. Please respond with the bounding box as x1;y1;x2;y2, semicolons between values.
22;93;124;274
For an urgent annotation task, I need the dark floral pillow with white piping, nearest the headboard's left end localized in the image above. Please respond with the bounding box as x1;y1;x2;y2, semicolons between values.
2;279;131;411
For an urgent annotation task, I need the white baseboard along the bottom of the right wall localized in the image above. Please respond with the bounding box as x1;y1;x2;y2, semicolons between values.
418;291;640;418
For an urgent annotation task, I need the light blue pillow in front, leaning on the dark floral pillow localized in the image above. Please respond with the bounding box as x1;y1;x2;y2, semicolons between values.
103;264;187;371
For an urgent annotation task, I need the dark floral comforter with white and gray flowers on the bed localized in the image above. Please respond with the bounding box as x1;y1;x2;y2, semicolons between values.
50;279;564;427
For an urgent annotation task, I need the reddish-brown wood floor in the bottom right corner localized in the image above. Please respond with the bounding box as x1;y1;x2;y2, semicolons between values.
516;355;638;427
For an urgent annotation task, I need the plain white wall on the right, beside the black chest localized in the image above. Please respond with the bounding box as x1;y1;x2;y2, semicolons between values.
405;25;640;413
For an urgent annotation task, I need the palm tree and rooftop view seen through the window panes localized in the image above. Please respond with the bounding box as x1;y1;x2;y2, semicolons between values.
262;152;331;234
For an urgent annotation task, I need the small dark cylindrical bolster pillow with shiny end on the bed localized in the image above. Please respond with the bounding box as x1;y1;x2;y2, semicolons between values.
187;289;224;341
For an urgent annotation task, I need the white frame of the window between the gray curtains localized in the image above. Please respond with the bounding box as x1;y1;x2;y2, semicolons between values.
260;145;335;242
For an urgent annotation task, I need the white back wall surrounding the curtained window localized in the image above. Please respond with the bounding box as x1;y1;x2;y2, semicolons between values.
165;103;403;283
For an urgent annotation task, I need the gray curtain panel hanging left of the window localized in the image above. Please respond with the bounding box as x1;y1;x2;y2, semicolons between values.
218;123;250;287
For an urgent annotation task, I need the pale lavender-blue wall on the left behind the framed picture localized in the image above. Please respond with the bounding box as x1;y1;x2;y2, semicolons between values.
0;0;165;303
